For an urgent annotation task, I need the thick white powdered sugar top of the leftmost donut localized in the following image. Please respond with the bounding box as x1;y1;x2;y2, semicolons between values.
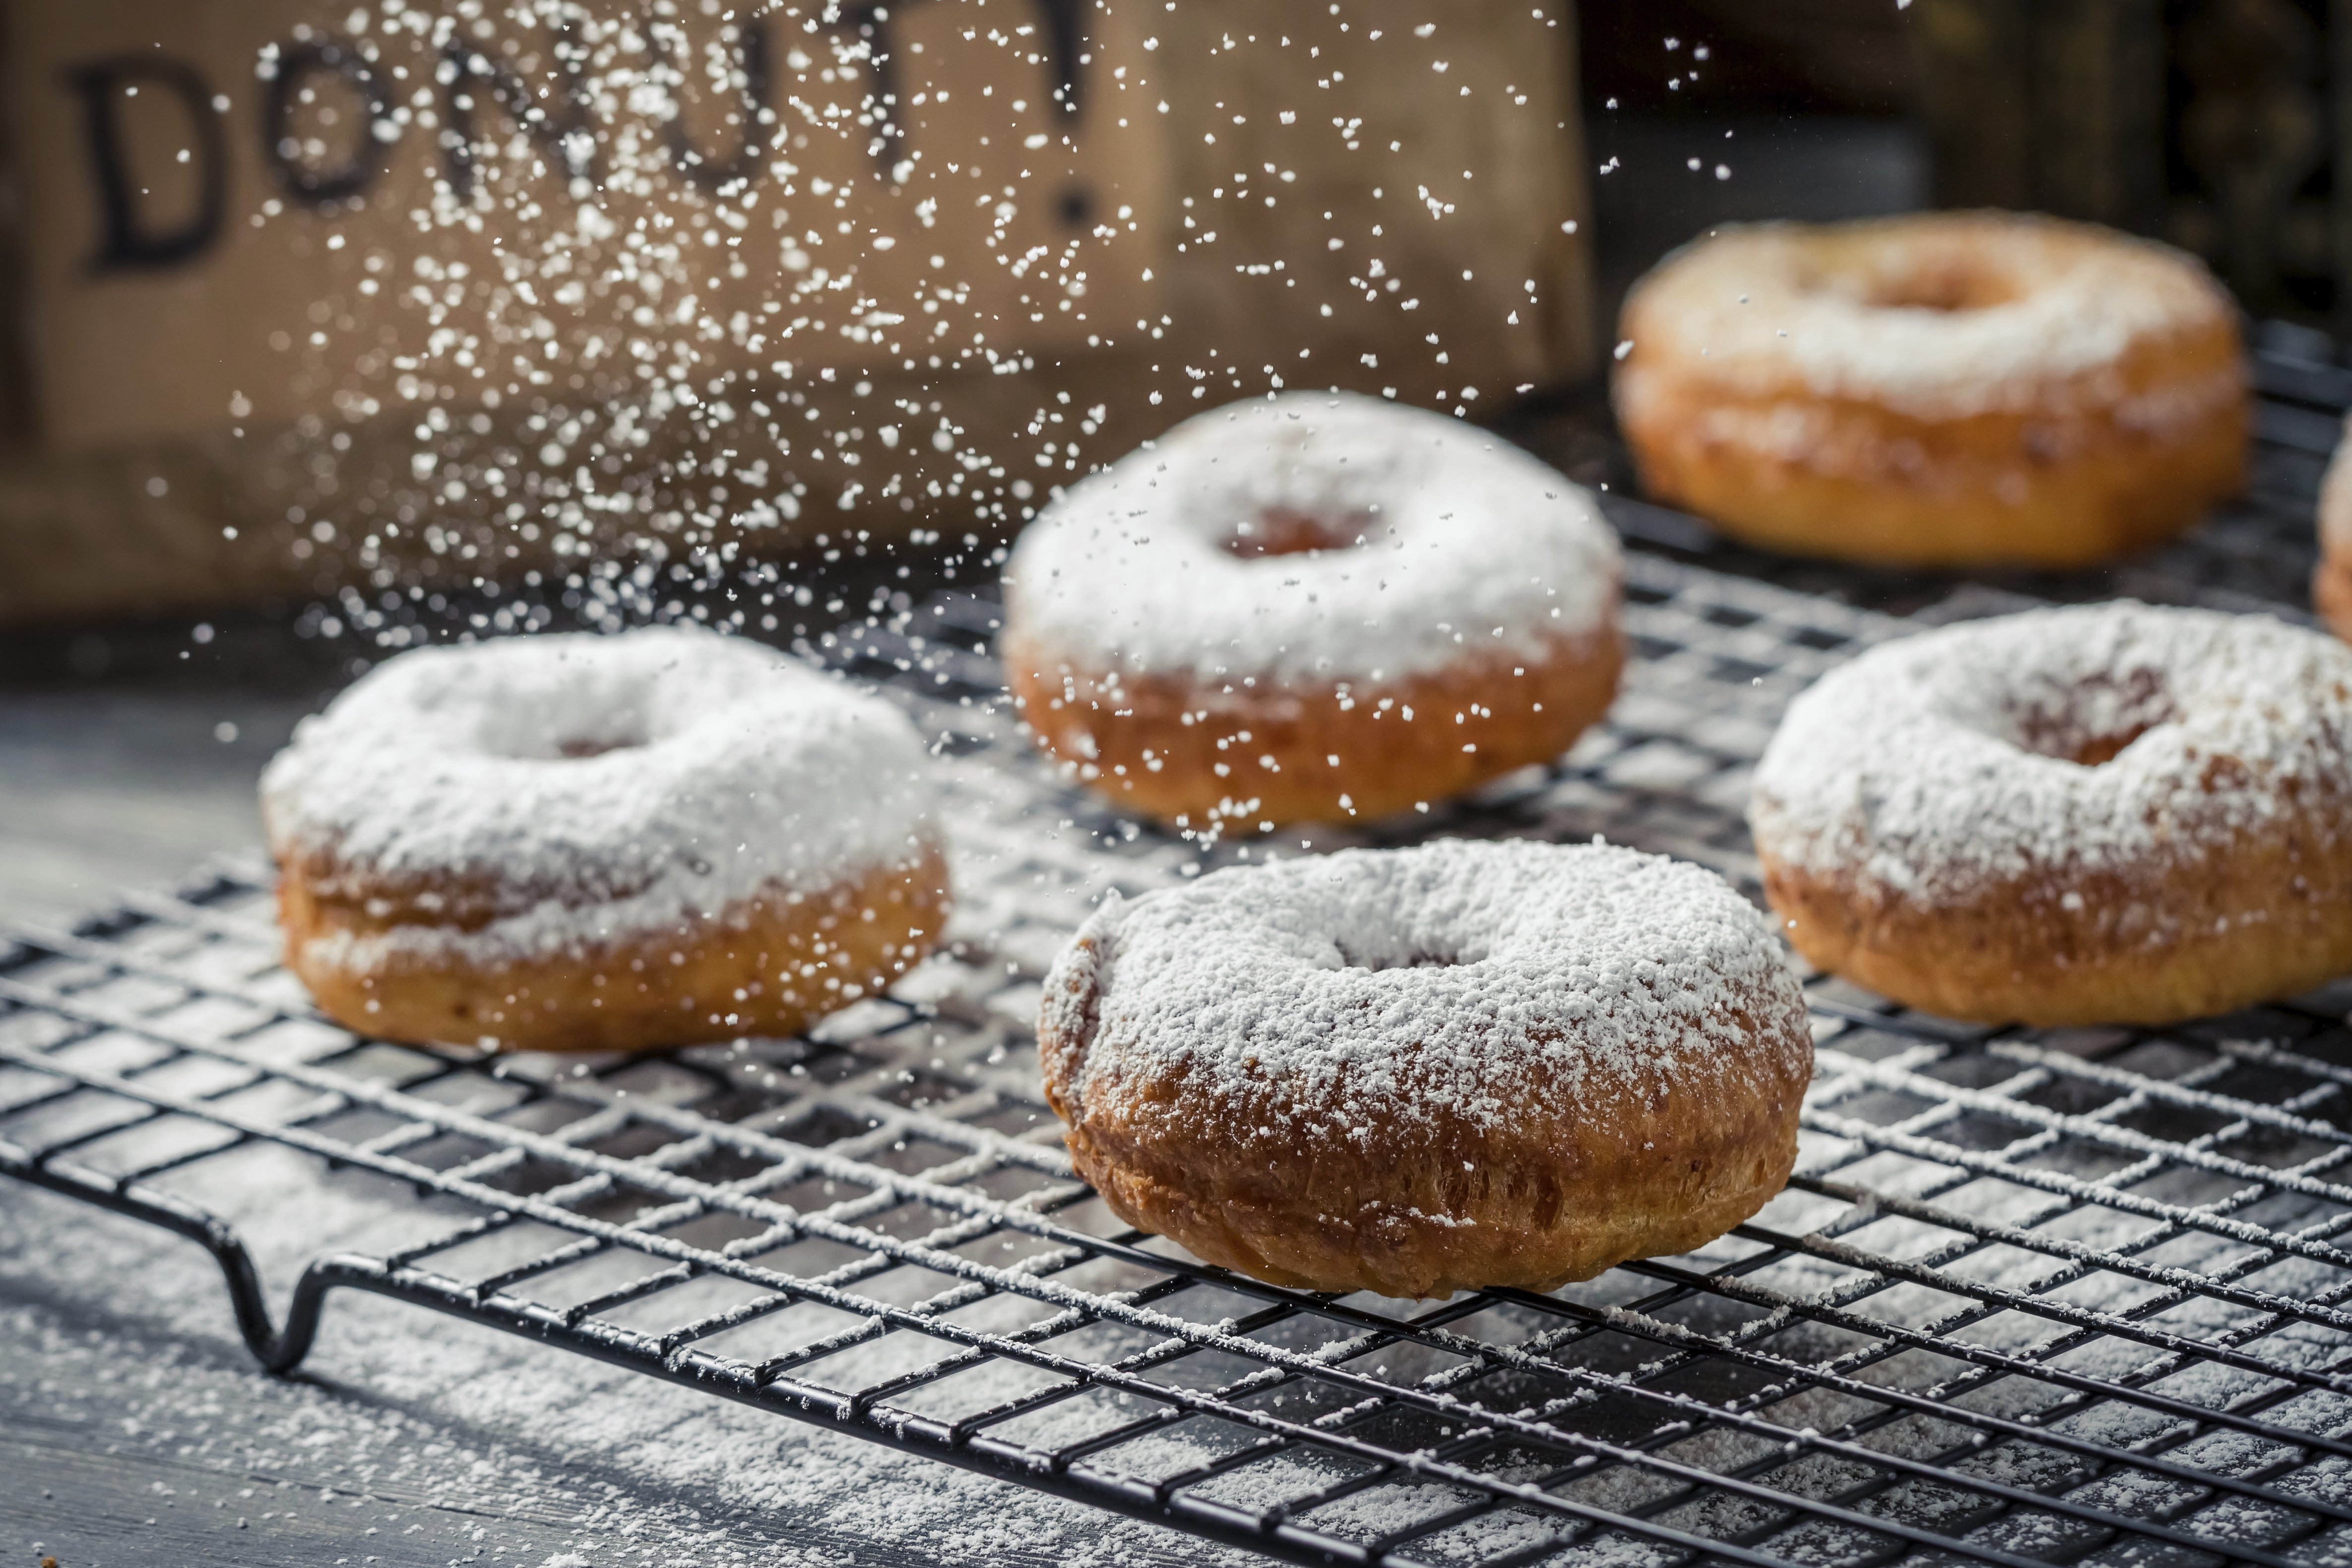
261;628;931;952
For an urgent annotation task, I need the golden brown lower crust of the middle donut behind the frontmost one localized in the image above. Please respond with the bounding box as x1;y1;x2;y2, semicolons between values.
1004;606;1625;828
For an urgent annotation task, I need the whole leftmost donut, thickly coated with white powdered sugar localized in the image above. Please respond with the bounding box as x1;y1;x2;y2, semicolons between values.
261;628;948;1051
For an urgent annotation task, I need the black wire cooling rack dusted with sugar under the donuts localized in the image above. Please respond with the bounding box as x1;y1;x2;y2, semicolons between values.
0;557;2352;1568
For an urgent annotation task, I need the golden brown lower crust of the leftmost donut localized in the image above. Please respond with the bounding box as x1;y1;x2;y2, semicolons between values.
278;844;948;1051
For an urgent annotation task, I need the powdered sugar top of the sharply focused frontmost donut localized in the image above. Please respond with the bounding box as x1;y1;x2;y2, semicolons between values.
1039;839;1811;1154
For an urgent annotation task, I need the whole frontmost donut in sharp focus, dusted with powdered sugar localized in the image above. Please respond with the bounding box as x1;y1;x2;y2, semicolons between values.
1037;842;1813;1295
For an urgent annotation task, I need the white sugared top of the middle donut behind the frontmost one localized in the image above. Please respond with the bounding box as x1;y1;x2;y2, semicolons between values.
1004;393;1621;682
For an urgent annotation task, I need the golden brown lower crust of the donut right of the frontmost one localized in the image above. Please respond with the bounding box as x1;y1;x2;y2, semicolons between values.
1759;832;2352;1027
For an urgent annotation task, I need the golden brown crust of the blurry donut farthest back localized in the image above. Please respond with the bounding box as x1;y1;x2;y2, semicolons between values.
1616;214;2251;566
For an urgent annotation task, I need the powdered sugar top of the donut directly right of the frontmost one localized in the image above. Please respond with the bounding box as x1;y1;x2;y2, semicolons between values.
1750;602;2352;905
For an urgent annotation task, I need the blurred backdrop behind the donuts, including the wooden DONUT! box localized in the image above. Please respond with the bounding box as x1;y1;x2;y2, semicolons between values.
0;0;2352;917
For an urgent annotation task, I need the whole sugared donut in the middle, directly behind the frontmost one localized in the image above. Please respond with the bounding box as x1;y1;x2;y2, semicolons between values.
1002;393;1623;830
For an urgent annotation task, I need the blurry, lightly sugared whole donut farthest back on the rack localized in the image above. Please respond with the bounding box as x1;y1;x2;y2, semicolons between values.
1616;212;2248;566
